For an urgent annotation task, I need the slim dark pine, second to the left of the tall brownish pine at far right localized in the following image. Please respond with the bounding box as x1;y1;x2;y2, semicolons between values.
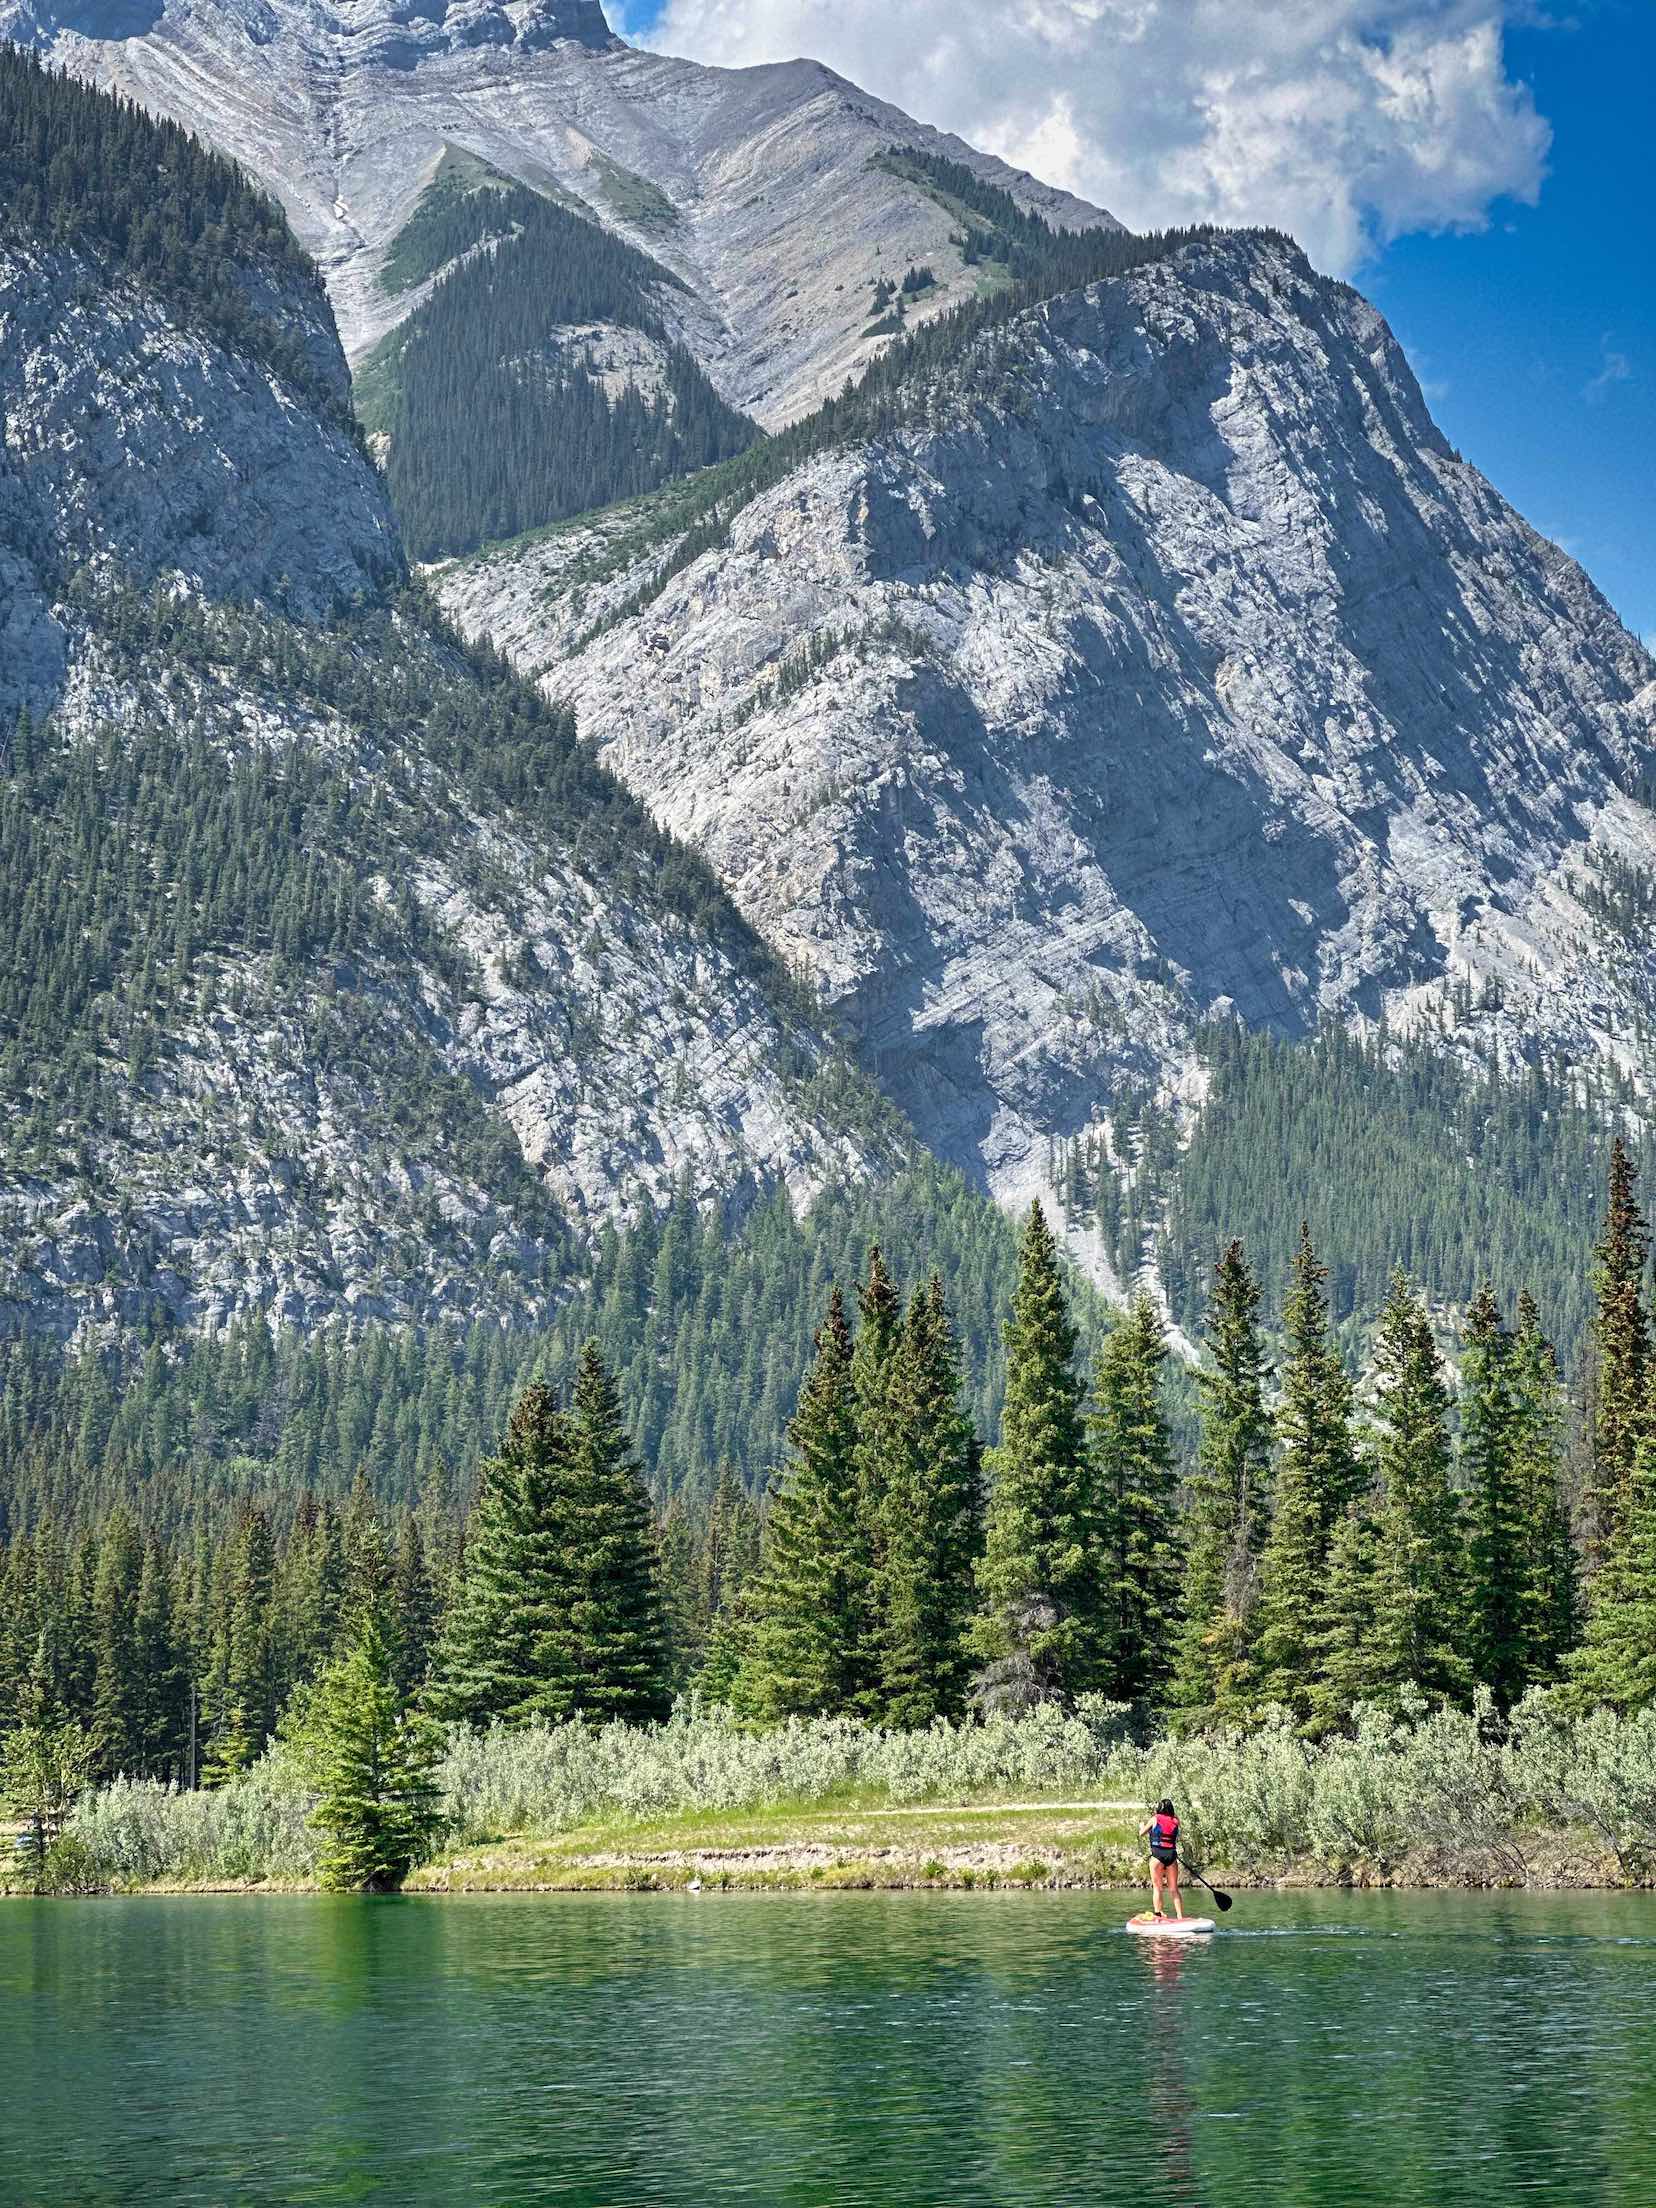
1459;1283;1535;1711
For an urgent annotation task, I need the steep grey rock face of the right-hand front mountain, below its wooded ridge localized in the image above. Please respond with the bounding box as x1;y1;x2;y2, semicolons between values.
439;238;1656;1195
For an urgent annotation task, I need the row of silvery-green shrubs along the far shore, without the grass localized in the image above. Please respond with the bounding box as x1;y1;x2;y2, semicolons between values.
71;1694;1656;1886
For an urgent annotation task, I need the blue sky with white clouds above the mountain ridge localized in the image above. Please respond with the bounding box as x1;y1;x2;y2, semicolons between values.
627;0;1656;645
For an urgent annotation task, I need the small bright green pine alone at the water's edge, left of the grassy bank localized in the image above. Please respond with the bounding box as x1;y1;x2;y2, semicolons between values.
298;1605;442;1894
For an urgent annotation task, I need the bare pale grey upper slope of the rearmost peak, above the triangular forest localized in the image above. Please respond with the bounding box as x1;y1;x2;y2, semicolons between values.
0;0;1108;426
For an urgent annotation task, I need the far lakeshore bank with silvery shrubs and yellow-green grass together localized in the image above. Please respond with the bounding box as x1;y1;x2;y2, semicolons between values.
22;1694;1656;1892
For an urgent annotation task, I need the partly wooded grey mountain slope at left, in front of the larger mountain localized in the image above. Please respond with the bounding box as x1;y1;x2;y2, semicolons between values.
0;51;903;1340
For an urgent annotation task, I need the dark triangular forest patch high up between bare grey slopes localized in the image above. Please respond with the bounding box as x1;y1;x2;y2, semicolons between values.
358;155;760;559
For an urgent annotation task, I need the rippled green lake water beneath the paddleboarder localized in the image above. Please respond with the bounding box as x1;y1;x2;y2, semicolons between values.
0;1894;1656;2208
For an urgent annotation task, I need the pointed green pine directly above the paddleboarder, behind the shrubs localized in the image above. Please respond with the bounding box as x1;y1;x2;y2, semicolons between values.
1089;1296;1181;1702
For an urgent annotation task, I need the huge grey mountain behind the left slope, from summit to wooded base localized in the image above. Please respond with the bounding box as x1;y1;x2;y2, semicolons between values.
0;0;1656;1329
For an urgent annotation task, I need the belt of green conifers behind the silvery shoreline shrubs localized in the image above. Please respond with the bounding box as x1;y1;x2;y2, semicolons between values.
0;1142;1656;1883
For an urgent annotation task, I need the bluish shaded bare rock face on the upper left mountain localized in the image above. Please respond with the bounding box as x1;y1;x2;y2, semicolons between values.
0;231;404;711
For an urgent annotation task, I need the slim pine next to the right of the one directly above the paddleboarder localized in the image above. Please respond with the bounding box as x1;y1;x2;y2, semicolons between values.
1172;1241;1272;1713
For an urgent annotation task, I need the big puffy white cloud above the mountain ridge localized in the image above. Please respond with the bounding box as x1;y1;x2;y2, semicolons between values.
636;0;1550;272
